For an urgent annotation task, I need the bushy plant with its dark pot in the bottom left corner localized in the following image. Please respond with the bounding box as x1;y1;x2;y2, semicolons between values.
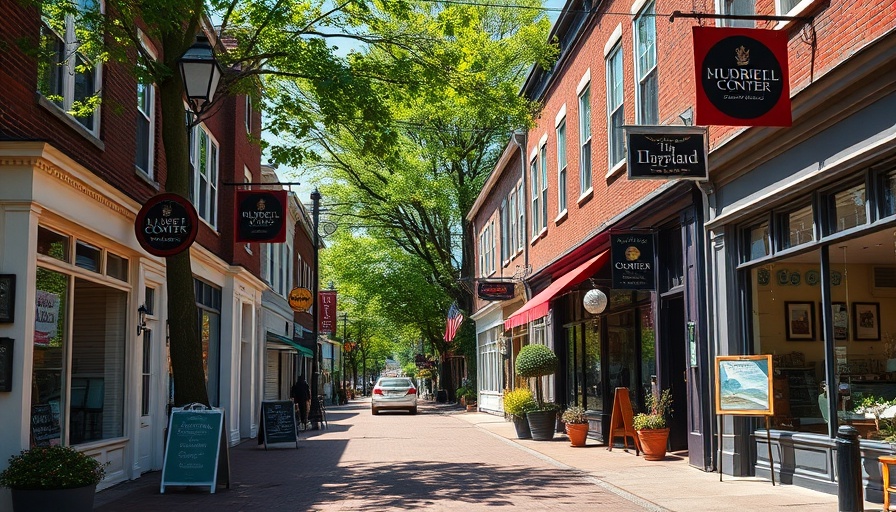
0;445;106;512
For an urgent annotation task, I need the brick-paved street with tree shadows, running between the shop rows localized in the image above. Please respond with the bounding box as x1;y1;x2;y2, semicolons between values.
95;402;644;512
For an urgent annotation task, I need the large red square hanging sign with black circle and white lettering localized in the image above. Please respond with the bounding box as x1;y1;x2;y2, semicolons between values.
693;27;792;126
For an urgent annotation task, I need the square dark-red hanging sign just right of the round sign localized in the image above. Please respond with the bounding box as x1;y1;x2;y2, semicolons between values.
233;190;287;244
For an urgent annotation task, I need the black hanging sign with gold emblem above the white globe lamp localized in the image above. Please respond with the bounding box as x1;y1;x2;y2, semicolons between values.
610;232;654;290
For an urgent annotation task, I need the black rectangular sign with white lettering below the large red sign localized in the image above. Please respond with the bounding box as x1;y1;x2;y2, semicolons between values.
625;126;709;180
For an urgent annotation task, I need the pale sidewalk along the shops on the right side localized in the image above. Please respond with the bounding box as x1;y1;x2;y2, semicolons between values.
446;410;882;512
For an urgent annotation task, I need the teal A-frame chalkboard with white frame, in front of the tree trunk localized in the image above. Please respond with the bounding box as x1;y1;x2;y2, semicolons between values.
160;407;229;493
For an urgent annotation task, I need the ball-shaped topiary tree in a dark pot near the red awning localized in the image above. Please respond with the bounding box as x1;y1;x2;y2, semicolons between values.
516;345;559;441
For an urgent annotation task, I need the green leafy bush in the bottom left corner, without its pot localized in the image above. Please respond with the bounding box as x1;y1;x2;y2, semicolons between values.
0;446;106;490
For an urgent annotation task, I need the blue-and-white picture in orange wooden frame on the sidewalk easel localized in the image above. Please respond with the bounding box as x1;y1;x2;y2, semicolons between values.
715;354;775;416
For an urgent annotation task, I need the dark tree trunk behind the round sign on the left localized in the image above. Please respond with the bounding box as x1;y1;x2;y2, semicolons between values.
157;73;210;407
